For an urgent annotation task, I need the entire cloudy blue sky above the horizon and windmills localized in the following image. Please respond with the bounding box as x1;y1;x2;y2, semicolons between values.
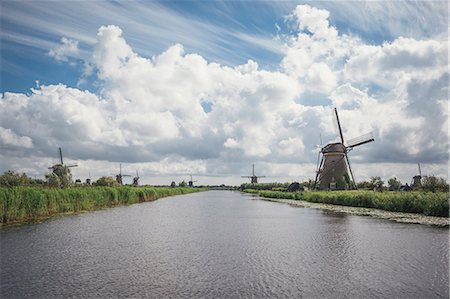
0;0;449;185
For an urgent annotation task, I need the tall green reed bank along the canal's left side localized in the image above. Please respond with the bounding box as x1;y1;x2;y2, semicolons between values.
0;186;206;225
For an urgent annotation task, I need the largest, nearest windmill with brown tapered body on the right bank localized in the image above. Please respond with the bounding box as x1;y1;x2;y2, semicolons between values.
314;108;374;190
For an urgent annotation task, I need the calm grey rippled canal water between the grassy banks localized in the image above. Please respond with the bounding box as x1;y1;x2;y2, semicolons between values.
0;191;449;298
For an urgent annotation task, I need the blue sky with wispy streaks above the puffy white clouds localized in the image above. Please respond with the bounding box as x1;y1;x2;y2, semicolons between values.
1;0;447;92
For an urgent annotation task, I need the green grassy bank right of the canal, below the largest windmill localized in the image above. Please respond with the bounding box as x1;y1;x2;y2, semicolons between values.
244;189;449;217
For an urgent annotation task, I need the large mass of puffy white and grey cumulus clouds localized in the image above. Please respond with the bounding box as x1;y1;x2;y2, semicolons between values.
0;5;448;184
